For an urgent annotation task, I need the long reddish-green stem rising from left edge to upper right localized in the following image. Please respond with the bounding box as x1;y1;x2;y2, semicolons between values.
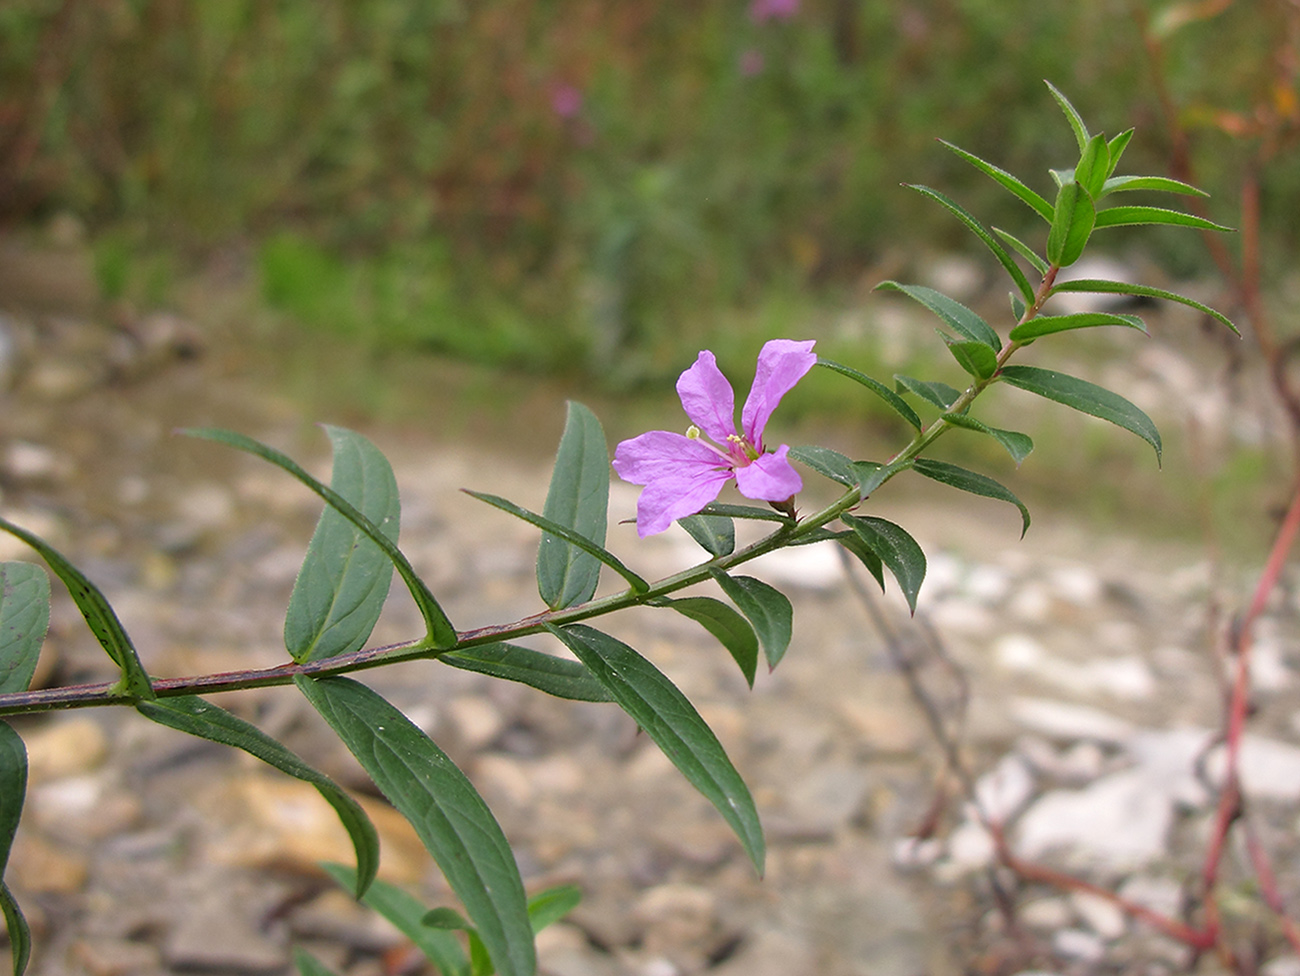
0;266;1058;716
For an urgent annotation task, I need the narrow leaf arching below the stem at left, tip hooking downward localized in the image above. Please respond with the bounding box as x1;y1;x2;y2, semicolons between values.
135;695;380;898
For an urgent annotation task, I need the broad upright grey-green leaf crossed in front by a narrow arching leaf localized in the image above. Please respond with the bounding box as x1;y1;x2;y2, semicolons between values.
285;425;402;664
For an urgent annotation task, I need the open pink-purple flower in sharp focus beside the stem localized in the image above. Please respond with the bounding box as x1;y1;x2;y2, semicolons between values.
614;339;816;538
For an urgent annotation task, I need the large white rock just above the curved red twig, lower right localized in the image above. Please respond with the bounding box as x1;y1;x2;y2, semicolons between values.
1017;769;1174;871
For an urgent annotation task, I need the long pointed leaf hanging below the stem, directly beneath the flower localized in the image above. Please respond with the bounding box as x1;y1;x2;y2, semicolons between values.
546;624;766;875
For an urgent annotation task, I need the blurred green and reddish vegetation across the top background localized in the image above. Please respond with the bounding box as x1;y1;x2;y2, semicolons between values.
0;0;1300;387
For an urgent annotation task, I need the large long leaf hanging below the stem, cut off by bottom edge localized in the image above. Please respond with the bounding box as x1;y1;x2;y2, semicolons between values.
294;674;537;976
